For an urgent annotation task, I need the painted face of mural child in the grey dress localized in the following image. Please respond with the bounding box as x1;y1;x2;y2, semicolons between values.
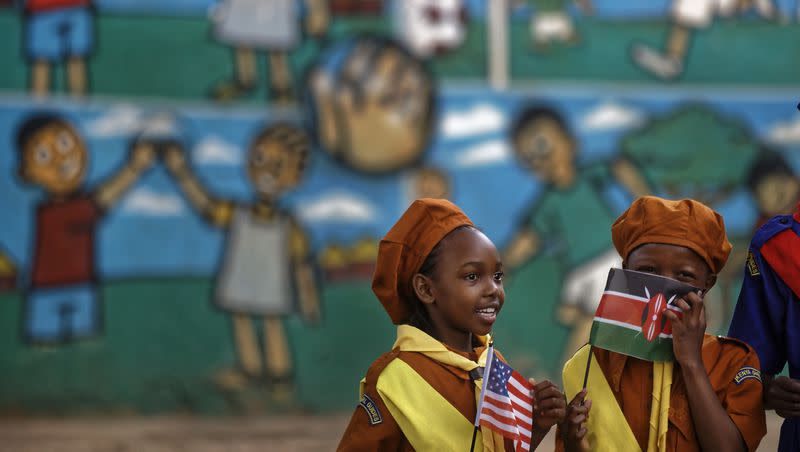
247;135;303;199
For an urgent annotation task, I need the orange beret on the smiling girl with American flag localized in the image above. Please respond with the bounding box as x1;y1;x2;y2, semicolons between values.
372;198;473;325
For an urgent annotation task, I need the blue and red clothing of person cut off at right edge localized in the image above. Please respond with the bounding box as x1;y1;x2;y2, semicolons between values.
728;206;800;452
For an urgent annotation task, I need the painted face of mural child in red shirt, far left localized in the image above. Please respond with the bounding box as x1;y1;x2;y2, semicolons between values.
21;122;88;195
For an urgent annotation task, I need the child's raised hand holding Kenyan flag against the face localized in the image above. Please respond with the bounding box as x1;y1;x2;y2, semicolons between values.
664;292;706;367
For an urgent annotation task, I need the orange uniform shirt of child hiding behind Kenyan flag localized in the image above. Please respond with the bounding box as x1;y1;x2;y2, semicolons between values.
556;334;767;452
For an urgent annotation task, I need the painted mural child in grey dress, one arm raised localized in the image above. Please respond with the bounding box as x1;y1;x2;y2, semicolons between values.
164;124;320;385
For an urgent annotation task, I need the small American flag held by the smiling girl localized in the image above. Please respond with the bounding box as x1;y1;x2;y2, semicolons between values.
475;346;533;451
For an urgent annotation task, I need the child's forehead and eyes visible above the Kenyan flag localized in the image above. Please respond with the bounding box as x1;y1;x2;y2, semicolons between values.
623;243;717;290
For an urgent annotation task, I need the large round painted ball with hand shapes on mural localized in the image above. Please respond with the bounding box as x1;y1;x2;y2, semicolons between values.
309;36;434;174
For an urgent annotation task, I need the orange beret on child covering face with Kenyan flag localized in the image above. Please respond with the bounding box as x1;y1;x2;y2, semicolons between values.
611;196;731;273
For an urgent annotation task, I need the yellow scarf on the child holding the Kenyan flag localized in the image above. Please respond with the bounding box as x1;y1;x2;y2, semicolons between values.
563;345;672;452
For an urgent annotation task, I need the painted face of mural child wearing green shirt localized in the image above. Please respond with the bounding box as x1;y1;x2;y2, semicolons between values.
514;117;575;188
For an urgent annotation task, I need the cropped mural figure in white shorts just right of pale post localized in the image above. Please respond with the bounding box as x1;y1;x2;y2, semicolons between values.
528;0;593;50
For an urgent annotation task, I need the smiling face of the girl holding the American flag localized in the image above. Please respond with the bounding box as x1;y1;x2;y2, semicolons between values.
413;228;505;351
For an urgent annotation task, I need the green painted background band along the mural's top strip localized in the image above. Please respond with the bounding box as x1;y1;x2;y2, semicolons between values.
0;11;800;103
